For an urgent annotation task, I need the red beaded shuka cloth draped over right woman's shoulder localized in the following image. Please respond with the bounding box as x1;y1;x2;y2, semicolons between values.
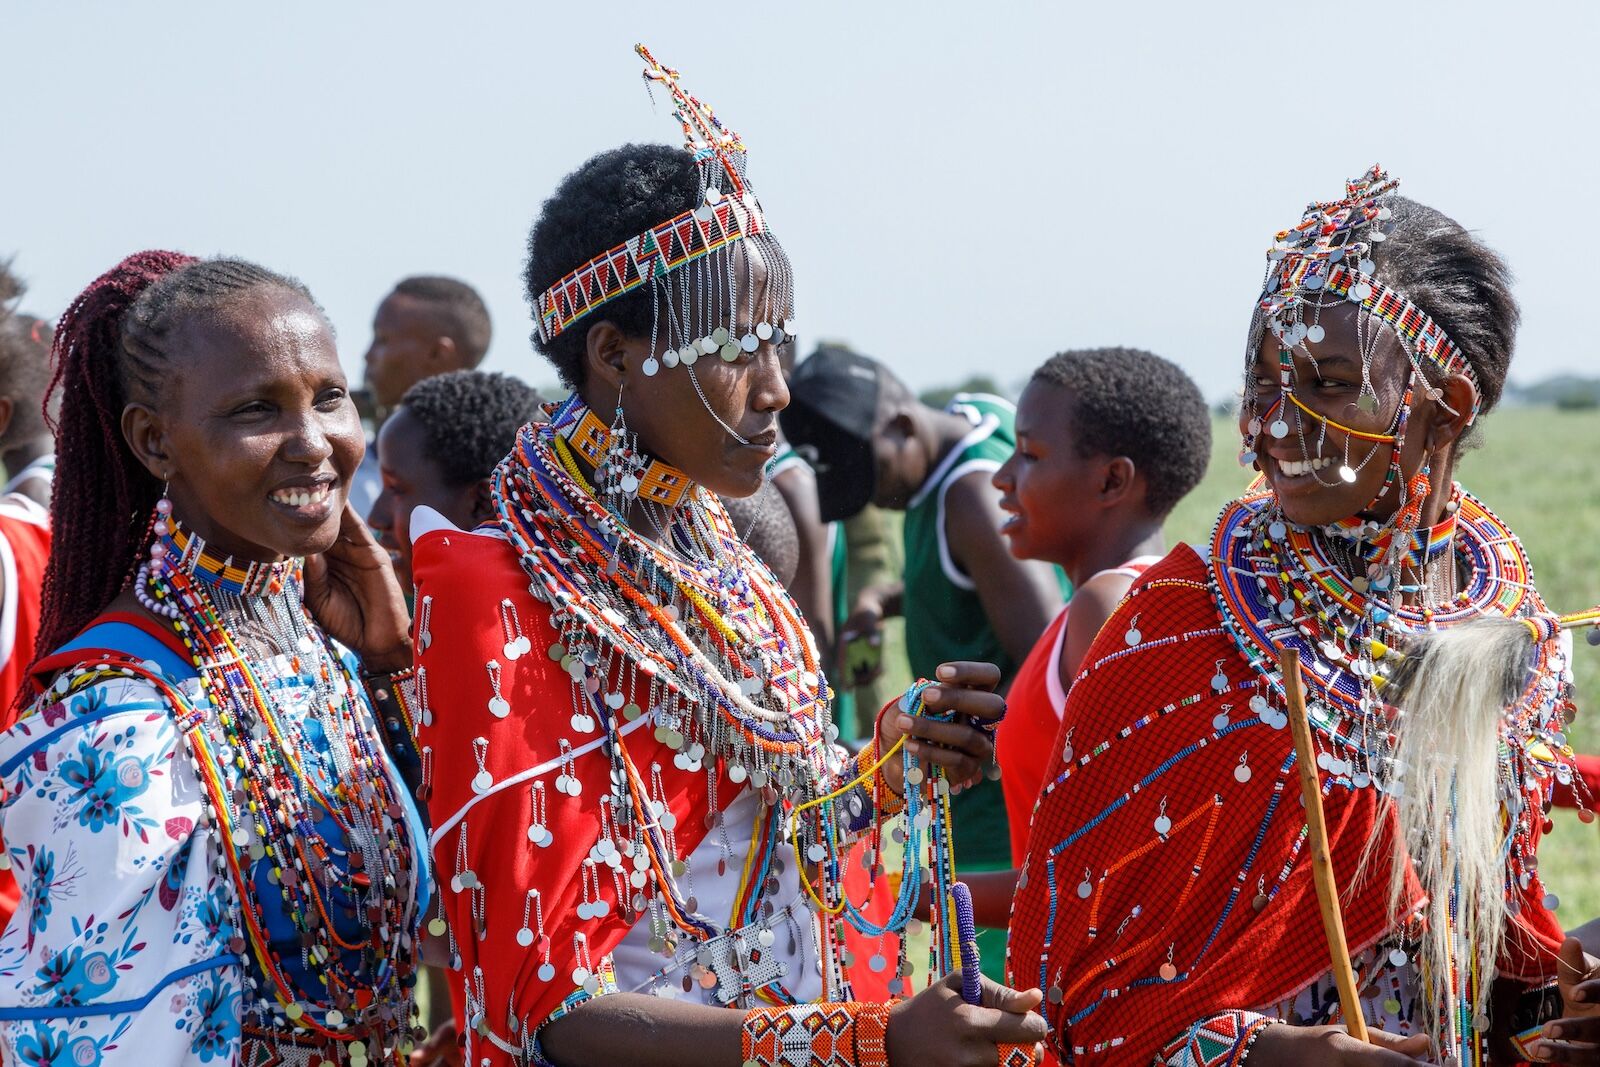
1006;545;1562;1064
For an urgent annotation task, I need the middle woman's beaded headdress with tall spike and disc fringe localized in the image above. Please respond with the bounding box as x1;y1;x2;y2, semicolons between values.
534;45;794;374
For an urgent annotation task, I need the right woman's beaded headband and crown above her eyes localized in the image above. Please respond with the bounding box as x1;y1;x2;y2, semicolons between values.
1251;163;1477;395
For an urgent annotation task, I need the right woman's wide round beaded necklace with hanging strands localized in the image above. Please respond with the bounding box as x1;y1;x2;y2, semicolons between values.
1210;486;1566;1062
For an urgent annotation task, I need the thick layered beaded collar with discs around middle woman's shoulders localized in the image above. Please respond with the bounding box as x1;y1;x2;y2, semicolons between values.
491;397;838;798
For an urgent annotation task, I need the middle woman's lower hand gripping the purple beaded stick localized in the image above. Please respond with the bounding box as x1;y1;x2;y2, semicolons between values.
885;971;1050;1067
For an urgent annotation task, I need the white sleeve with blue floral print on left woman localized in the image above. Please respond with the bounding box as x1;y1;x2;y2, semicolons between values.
0;677;240;1067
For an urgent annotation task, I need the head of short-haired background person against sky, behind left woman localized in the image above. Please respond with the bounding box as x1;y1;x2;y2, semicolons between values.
366;275;491;411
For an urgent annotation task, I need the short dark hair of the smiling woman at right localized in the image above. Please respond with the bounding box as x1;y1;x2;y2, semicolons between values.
1370;195;1522;413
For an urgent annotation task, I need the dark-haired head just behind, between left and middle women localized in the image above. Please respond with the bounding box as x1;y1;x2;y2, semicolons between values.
366;371;541;592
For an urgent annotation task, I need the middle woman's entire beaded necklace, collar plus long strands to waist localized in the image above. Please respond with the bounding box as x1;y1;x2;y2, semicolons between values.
491;397;960;1001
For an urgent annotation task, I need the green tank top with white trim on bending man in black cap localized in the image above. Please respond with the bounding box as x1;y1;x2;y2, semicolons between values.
904;394;1056;883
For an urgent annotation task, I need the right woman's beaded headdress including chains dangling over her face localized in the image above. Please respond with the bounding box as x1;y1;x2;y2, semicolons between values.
1240;163;1478;531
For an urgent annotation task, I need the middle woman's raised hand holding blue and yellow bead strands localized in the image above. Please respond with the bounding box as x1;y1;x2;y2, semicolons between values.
878;659;1005;793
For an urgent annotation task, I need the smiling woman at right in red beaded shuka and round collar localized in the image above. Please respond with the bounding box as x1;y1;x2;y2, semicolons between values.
1008;168;1600;1065
